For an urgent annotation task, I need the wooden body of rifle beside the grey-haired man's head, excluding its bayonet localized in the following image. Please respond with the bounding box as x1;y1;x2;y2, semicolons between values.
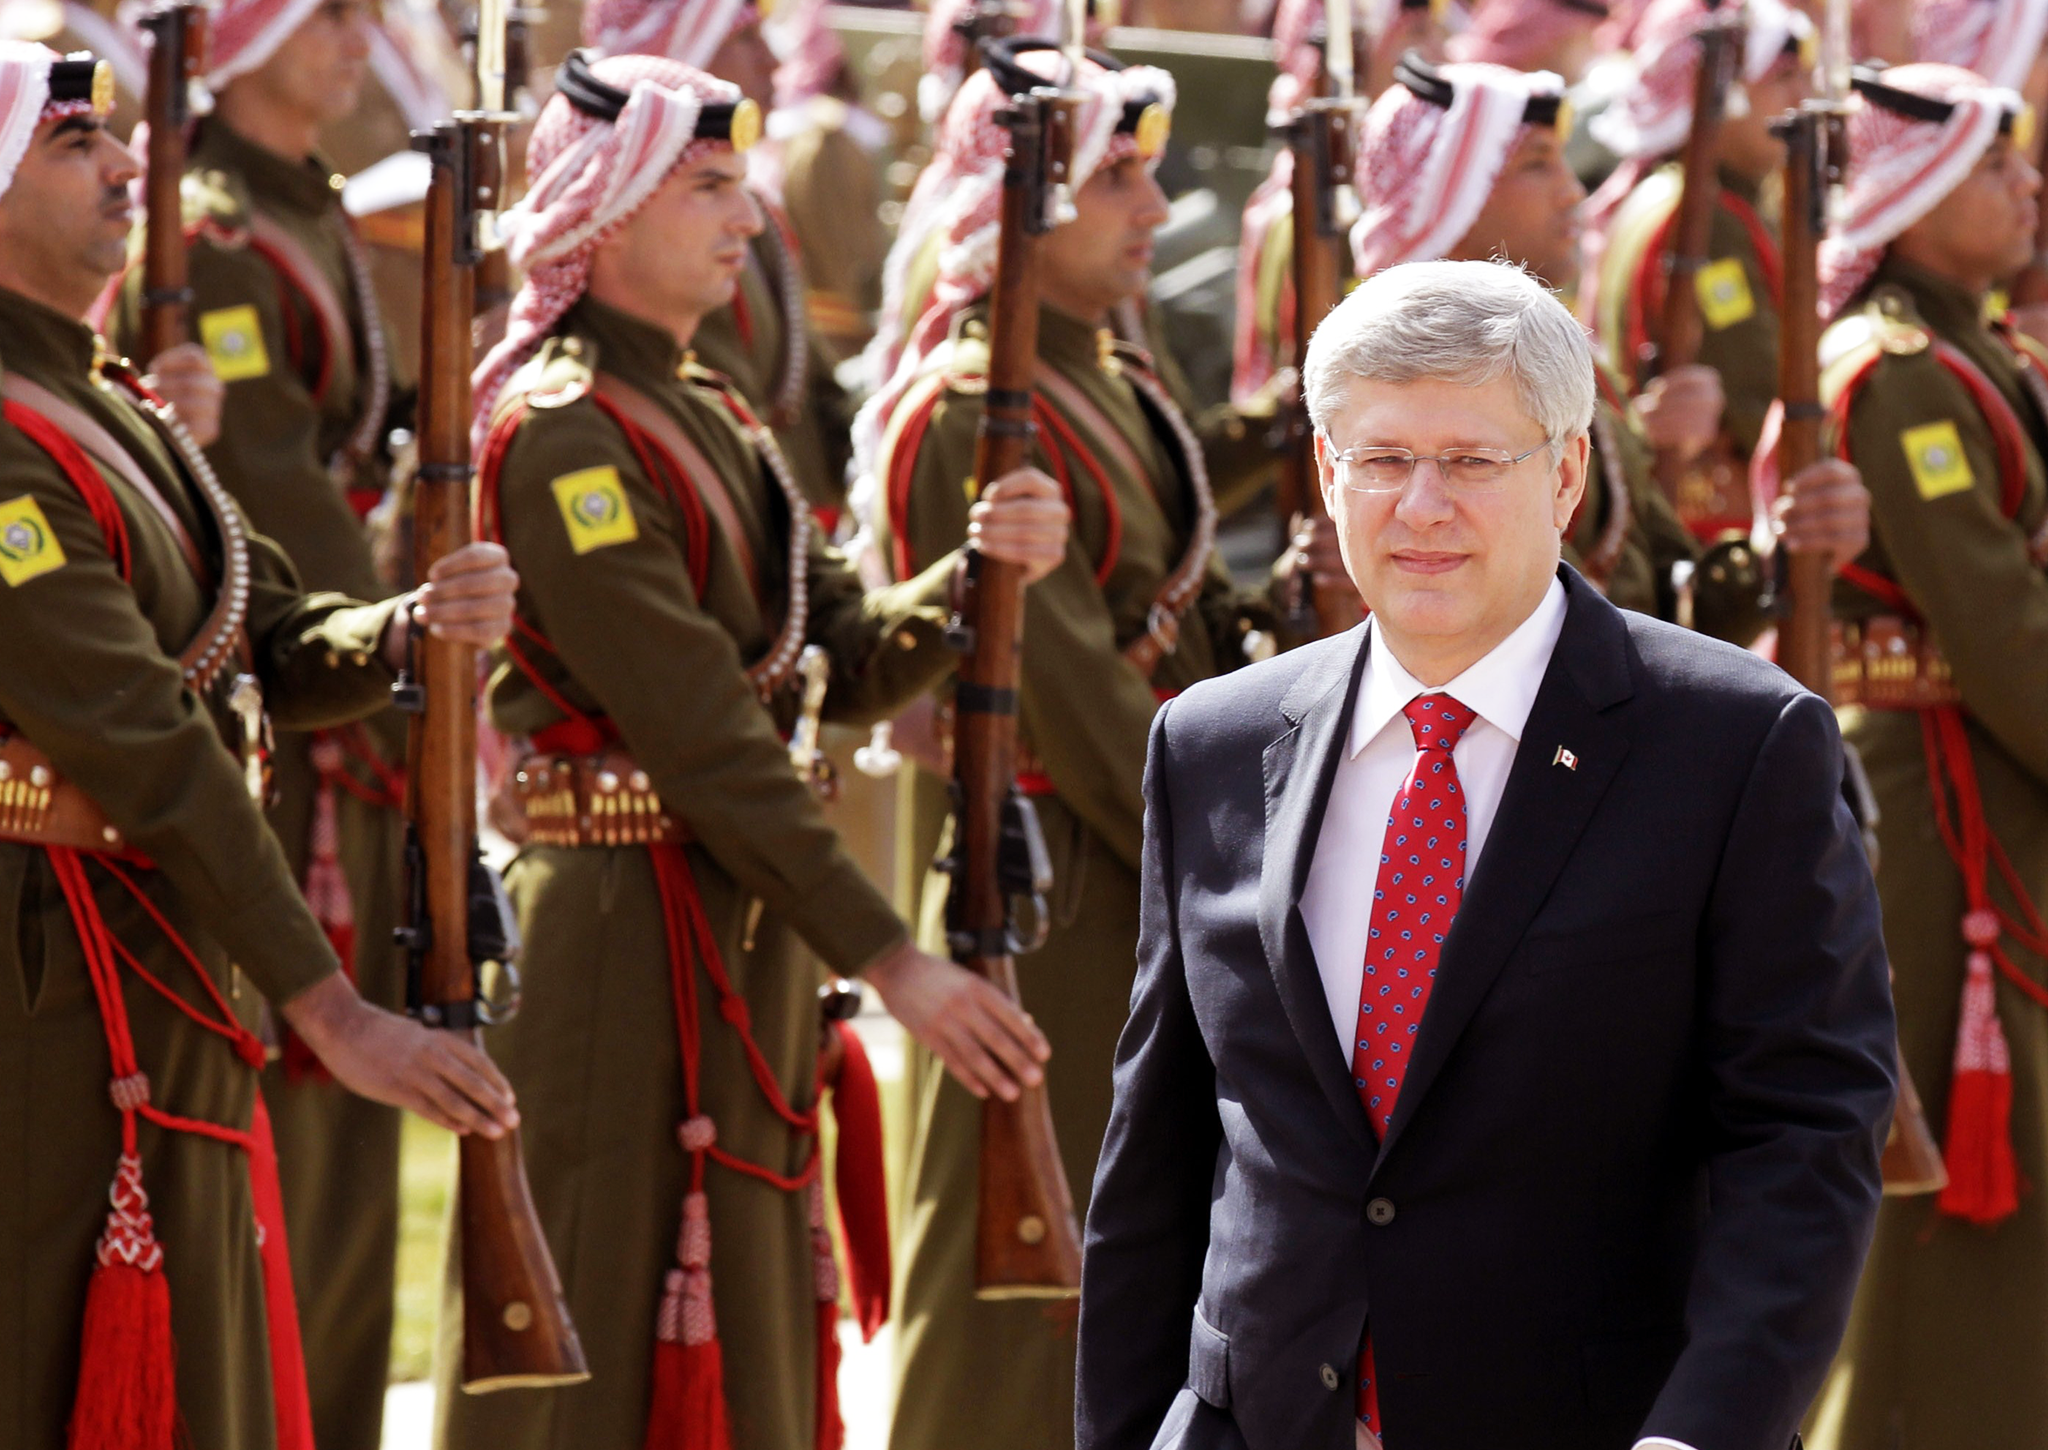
1282;98;1366;635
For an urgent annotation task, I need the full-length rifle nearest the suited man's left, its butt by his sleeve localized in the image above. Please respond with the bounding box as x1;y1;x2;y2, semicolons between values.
944;39;1081;1298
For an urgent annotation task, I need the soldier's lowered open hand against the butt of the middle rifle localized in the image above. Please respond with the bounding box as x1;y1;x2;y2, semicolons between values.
860;942;1053;1102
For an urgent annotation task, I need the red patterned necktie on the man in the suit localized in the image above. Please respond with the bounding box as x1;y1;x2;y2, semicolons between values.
1352;694;1479;1434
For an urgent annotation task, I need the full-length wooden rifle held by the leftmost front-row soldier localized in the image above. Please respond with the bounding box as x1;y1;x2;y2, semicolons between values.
393;0;590;1393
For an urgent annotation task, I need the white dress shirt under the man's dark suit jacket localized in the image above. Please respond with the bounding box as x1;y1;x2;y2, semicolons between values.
1300;580;1692;1450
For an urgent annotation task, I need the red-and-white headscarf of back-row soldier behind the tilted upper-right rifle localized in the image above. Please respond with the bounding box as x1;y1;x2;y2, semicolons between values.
1589;0;1812;160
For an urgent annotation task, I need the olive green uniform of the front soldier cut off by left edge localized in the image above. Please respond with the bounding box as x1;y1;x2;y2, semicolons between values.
0;278;403;1450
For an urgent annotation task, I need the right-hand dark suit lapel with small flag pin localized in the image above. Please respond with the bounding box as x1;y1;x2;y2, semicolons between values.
1368;569;1632;1163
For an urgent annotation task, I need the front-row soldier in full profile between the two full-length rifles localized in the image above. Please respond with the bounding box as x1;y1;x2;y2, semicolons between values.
438;55;1067;1450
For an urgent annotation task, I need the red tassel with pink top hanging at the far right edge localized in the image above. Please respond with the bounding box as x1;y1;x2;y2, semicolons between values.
1937;942;2019;1225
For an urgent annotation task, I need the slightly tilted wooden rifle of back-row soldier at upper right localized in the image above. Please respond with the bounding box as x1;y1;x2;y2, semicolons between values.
1638;0;1743;502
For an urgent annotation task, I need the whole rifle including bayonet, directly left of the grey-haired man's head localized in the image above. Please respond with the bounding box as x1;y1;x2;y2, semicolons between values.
1280;0;1364;635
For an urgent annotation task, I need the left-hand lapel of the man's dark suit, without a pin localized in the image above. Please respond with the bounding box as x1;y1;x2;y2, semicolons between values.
1260;629;1372;1155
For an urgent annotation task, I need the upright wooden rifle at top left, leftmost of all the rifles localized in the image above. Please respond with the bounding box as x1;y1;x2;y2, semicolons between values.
141;4;207;367
